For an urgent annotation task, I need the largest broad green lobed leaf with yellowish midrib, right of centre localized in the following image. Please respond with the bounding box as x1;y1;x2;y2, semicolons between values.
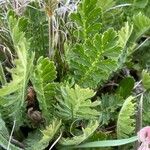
69;28;123;89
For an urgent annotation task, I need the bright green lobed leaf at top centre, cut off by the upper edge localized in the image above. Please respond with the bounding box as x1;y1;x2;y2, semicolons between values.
70;0;101;40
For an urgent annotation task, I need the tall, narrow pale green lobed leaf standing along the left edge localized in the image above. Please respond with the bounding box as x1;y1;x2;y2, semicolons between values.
0;11;34;126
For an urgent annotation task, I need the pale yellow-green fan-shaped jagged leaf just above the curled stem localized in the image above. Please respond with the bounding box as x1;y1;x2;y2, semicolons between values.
56;85;100;121
